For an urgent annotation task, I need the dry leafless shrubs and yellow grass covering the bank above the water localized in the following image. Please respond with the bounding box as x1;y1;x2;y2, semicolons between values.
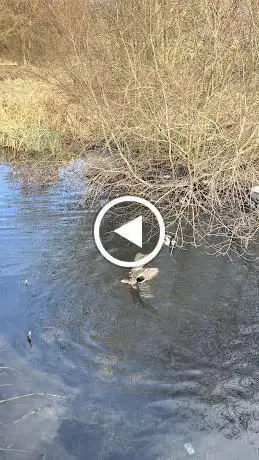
0;0;259;252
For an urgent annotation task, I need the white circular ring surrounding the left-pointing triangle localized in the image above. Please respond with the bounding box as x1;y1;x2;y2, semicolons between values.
94;195;165;268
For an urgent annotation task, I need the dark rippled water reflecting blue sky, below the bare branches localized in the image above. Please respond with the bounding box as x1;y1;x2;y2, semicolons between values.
0;165;259;460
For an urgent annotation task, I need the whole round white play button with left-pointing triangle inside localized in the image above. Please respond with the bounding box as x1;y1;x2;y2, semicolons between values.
94;195;165;268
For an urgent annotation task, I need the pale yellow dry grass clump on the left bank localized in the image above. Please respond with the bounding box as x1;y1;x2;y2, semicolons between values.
0;78;73;159
